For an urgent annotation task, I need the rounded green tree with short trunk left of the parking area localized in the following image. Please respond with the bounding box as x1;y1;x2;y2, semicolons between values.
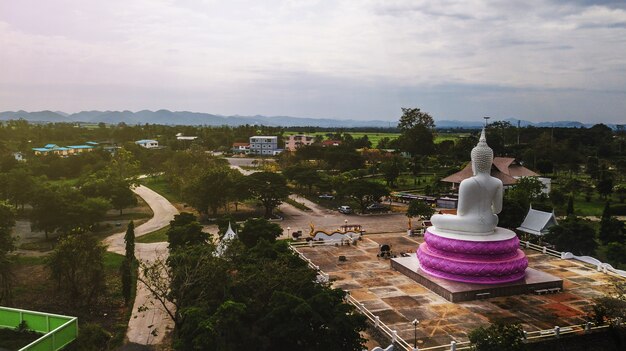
248;172;289;218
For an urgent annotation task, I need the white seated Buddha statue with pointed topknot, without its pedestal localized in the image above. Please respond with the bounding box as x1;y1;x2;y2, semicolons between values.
431;129;503;235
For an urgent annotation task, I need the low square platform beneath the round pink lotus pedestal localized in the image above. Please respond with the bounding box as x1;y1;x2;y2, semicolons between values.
391;254;563;302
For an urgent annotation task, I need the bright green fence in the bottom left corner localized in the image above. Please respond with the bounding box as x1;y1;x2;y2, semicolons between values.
0;306;78;351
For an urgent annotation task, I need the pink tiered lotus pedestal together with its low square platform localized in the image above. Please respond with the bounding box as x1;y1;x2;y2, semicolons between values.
391;227;563;302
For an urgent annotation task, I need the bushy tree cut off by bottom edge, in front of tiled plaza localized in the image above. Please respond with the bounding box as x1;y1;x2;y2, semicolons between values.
467;323;526;351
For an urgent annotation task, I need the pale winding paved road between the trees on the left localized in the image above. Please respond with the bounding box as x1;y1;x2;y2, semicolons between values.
104;185;178;345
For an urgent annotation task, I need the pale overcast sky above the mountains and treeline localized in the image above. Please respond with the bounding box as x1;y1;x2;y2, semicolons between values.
0;0;626;123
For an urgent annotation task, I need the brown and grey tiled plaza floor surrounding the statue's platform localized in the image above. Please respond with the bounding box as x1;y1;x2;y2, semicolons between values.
298;233;615;347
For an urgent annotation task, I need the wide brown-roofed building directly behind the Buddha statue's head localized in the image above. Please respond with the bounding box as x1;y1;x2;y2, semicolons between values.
441;157;551;194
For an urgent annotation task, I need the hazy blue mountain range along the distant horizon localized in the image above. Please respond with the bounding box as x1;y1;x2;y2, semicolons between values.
0;110;615;129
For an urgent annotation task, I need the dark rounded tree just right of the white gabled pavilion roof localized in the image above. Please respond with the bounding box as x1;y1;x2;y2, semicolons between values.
545;216;598;256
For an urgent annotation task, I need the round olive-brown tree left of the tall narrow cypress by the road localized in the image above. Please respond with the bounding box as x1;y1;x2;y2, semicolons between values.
47;234;106;306
